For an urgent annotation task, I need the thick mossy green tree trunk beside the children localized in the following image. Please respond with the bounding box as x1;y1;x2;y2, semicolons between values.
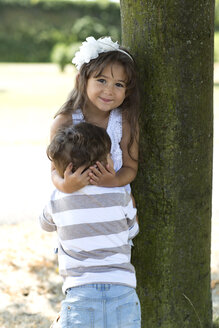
120;0;214;328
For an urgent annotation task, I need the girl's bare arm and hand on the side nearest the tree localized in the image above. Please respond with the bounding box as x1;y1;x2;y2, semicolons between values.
89;121;139;187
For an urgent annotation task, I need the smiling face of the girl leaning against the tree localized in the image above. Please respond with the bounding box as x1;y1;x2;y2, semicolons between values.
86;63;126;112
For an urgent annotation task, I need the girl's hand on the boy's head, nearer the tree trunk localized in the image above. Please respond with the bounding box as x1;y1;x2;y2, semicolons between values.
89;162;116;187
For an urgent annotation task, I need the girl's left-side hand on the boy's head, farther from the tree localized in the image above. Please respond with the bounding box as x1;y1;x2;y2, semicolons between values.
52;163;90;193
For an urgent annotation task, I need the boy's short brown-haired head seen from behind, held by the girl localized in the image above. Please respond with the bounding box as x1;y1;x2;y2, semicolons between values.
46;122;111;177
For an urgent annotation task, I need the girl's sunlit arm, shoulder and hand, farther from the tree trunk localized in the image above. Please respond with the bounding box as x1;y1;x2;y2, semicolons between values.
50;114;90;193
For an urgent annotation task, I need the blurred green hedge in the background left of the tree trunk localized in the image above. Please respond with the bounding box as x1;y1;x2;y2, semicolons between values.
0;0;120;62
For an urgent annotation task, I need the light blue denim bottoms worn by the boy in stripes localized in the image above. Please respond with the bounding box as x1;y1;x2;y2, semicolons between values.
60;284;141;328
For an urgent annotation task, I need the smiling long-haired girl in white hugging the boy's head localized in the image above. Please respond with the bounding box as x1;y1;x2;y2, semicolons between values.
51;37;139;193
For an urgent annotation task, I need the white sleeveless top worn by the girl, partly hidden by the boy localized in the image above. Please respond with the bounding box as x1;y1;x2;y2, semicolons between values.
72;108;131;192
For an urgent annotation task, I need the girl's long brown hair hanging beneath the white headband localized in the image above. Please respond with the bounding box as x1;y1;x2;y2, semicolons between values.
55;47;139;157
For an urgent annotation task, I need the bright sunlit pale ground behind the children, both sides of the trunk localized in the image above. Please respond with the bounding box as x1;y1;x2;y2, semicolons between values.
0;64;219;315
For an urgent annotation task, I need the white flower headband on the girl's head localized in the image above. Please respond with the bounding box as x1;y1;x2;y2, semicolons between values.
72;36;133;70
